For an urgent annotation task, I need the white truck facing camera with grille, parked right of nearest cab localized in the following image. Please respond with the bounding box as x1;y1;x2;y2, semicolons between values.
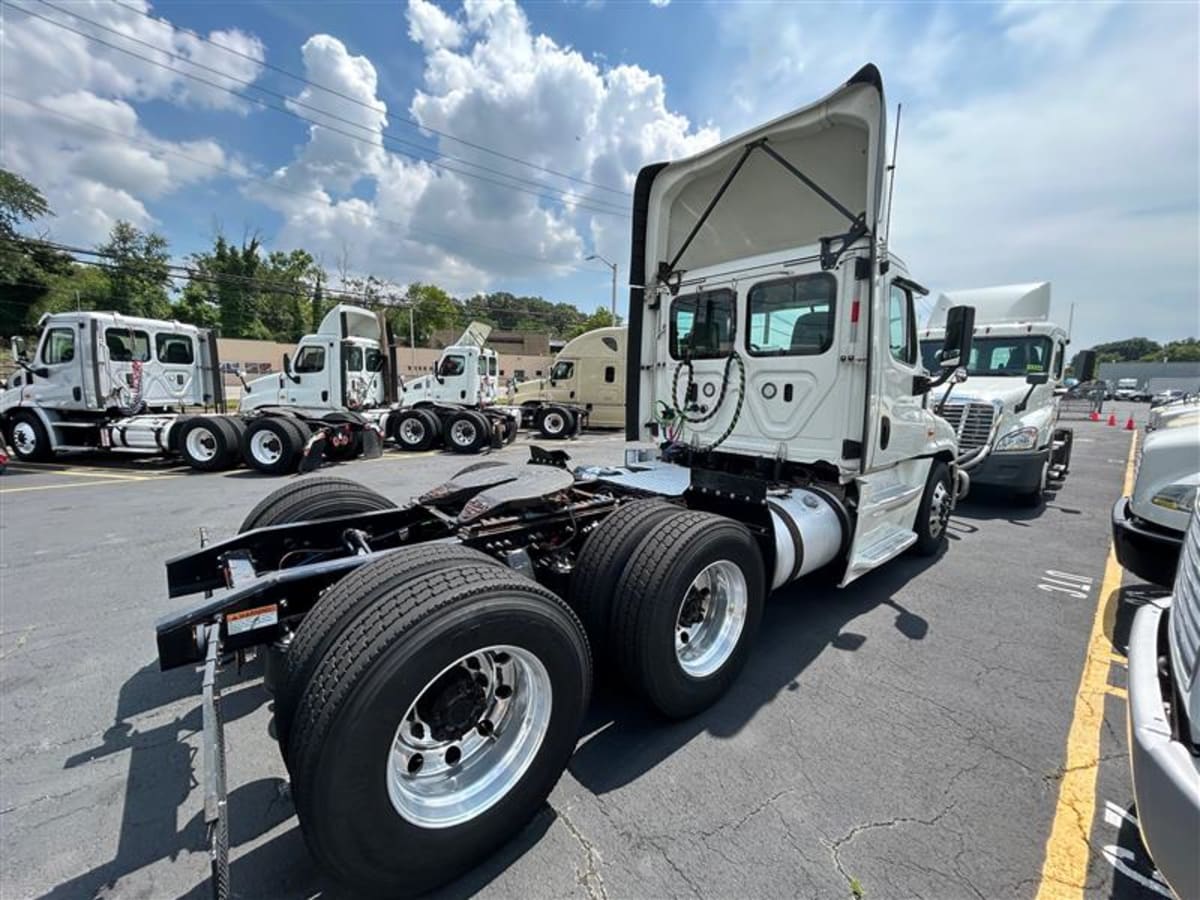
922;282;1094;505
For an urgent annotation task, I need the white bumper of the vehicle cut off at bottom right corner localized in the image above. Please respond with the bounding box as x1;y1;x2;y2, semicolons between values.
1127;600;1200;898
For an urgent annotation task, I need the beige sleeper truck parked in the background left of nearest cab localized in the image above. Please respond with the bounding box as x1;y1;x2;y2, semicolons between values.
509;326;629;438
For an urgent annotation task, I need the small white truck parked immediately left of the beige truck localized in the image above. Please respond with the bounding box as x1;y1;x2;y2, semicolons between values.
388;322;521;454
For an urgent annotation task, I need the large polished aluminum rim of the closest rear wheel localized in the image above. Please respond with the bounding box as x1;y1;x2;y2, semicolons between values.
388;644;553;828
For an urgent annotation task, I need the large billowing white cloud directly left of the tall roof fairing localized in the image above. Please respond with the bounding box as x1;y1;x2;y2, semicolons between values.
250;0;718;290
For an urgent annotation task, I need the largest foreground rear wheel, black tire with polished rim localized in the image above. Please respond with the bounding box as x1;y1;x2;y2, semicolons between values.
289;565;592;896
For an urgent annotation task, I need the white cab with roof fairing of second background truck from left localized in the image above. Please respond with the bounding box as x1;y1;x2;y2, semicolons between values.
240;304;389;416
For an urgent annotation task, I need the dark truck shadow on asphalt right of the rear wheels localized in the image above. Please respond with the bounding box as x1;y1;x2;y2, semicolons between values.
569;557;937;794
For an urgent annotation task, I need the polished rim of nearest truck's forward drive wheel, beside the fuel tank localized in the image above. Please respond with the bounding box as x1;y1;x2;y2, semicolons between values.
674;559;750;678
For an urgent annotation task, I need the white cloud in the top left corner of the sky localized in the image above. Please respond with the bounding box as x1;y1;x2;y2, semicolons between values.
0;1;264;244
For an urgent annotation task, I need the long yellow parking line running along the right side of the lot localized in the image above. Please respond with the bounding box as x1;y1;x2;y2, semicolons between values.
1038;432;1138;900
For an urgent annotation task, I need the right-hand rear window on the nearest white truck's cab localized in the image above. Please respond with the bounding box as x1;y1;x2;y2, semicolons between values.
746;272;838;356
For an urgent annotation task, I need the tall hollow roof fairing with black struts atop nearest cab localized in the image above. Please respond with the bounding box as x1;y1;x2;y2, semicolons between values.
644;65;887;287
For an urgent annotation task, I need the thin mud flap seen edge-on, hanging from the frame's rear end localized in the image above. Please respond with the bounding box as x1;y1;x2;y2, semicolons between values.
200;624;230;900
